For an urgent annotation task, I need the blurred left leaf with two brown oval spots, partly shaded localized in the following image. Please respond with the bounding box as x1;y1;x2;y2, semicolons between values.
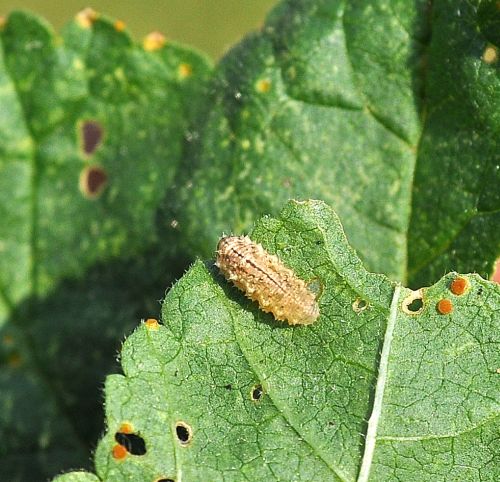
0;10;210;480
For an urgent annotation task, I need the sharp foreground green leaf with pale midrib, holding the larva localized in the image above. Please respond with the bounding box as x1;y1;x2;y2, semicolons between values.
61;201;500;482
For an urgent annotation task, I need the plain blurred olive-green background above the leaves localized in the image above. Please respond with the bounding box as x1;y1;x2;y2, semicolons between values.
0;0;276;58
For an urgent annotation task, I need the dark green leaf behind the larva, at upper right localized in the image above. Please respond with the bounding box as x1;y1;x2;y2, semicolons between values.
174;0;500;287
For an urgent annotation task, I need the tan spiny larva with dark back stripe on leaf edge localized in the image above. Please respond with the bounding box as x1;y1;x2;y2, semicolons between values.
215;236;319;325
